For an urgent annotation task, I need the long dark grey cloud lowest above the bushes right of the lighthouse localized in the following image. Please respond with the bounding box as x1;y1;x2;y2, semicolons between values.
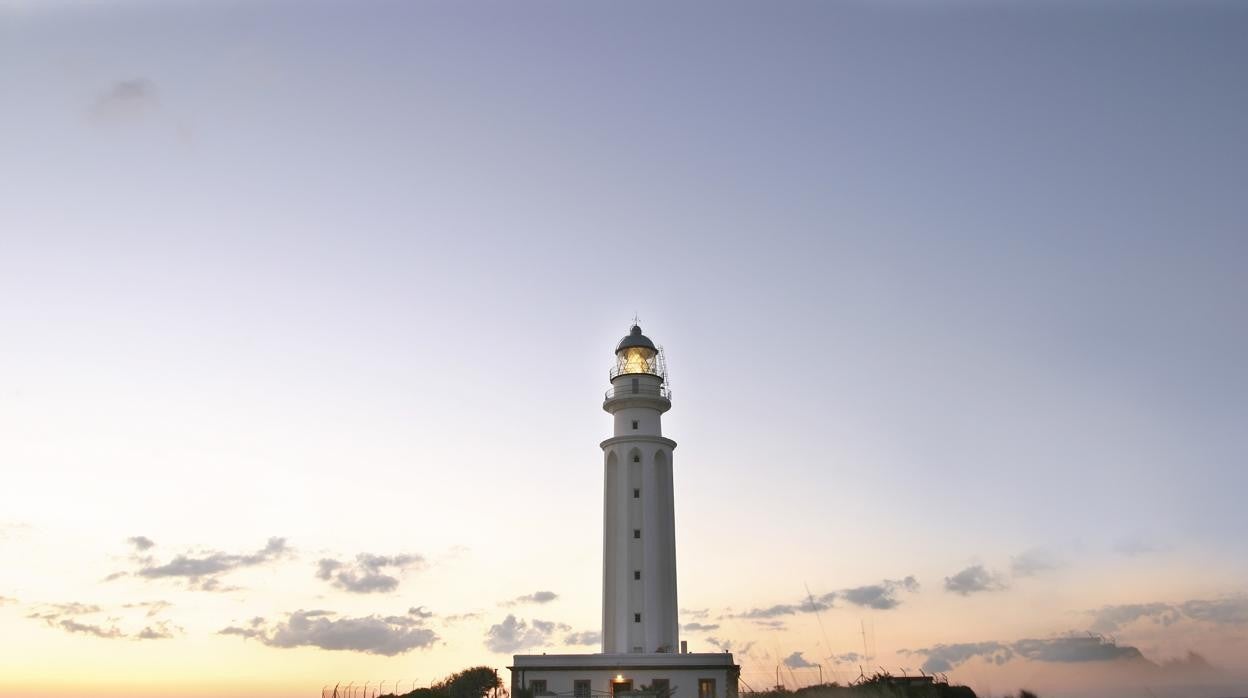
904;636;1147;672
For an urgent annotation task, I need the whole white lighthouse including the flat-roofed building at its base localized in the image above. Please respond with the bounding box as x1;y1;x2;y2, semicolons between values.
508;325;740;698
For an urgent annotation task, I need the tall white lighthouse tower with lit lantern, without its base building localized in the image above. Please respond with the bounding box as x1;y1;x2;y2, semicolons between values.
602;325;680;654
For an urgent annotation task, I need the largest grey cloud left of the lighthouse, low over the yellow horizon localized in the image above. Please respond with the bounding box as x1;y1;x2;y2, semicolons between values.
217;609;438;657
